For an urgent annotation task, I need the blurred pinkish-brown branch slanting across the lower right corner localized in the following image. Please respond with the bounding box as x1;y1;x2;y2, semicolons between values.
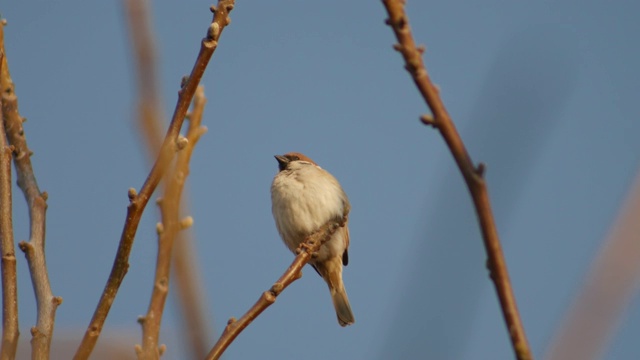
546;174;640;360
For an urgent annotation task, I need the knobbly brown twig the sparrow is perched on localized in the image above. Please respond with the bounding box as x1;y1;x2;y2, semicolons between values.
206;215;347;360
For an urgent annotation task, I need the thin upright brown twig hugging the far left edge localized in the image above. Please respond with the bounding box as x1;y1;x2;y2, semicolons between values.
0;50;20;360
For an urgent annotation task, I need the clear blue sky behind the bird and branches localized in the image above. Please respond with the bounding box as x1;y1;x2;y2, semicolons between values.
2;0;640;359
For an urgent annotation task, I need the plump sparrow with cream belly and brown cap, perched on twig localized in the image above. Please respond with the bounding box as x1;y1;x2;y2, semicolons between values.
271;152;355;326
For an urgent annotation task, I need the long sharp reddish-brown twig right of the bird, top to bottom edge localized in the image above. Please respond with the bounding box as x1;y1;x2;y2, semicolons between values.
382;0;533;359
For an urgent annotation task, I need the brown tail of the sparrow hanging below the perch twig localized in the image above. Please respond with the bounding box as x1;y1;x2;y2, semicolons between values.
316;257;355;326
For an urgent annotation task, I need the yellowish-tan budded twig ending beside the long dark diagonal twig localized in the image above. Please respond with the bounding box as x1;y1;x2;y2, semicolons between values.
136;86;206;359
